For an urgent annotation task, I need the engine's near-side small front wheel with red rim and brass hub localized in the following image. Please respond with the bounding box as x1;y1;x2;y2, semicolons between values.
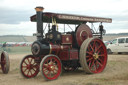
41;56;61;80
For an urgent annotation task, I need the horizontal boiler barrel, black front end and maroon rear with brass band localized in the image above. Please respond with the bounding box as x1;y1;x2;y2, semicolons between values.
31;41;70;56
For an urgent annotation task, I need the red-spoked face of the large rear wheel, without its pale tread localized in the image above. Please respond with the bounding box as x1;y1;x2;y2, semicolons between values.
86;39;107;73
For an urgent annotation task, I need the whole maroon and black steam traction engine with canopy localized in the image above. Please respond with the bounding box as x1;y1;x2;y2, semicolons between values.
20;7;112;80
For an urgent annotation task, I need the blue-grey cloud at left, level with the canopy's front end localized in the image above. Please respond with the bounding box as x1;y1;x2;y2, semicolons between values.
0;7;32;24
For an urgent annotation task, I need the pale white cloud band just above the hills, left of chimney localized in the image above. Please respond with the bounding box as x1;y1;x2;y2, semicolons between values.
0;21;36;35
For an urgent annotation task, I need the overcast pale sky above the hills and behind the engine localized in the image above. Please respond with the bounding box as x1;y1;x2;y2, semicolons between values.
0;0;128;35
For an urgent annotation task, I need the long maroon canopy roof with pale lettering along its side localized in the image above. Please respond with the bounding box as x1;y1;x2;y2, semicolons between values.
30;12;112;24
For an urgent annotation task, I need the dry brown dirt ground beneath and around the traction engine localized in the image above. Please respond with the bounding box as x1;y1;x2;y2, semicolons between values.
0;54;128;85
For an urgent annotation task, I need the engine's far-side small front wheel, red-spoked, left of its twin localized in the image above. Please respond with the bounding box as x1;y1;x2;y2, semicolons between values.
20;55;39;78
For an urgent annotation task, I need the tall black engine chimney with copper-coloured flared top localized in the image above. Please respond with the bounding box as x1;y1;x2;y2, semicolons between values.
35;7;44;40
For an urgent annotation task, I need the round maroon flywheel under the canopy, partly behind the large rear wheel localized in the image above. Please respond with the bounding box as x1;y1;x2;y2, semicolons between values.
76;24;92;47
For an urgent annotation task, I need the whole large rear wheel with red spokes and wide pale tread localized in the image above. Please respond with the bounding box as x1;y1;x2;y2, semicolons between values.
80;38;107;73
